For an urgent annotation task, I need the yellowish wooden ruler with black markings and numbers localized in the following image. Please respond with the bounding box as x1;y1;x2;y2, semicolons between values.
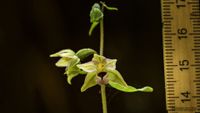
161;0;200;113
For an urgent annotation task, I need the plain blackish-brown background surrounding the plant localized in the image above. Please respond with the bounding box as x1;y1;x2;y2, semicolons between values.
0;0;166;113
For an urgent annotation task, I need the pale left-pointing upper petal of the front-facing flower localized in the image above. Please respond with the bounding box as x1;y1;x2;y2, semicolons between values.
77;61;97;73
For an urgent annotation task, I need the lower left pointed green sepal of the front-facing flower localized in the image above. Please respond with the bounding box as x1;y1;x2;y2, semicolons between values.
81;72;97;92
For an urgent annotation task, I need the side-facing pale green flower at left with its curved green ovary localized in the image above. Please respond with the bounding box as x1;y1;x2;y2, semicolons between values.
50;48;96;84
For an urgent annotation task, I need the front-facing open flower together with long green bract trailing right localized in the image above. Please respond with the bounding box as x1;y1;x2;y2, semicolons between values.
77;54;153;92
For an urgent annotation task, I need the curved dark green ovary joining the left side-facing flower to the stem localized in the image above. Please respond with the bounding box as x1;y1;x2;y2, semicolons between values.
75;48;96;60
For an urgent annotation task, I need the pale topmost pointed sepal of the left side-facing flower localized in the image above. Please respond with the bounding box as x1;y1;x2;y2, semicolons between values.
50;49;75;58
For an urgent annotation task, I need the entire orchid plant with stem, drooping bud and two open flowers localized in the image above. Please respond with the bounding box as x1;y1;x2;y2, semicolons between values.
50;1;153;113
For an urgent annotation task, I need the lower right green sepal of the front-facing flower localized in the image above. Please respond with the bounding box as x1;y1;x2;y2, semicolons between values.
107;70;127;87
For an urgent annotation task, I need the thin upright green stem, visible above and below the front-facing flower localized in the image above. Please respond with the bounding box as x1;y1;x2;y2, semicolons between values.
100;5;107;113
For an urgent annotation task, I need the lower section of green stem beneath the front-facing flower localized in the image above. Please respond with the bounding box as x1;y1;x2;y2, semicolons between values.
101;85;107;113
